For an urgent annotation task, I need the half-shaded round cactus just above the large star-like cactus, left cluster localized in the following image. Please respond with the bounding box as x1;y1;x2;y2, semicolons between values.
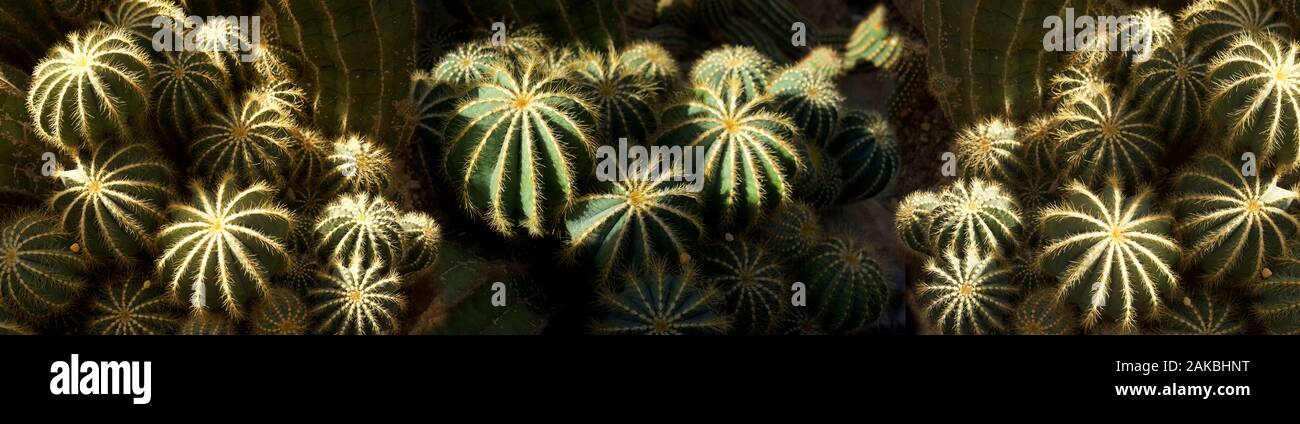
189;98;294;183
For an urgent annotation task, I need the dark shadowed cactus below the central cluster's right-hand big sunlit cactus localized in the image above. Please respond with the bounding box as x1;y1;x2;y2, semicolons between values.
699;241;789;334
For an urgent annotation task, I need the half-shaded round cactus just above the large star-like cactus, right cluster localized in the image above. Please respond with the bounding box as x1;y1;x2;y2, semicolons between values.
1056;94;1165;185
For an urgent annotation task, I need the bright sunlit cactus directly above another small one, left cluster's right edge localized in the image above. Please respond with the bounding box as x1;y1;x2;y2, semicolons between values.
315;192;402;265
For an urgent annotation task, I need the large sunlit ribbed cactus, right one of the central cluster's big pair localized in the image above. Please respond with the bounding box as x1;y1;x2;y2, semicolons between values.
658;82;803;228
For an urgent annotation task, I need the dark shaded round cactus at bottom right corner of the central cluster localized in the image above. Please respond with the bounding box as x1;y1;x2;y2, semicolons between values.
800;238;889;333
